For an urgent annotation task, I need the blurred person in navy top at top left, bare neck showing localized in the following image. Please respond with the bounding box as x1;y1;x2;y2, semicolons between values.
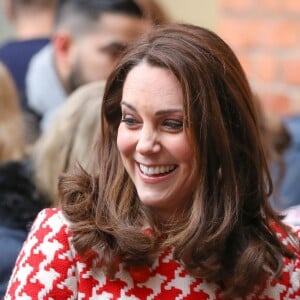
0;0;58;141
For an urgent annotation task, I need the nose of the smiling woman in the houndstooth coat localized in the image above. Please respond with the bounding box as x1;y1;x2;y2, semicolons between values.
136;128;161;154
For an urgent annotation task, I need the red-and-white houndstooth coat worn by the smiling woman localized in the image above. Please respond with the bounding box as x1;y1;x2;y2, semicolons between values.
5;209;300;300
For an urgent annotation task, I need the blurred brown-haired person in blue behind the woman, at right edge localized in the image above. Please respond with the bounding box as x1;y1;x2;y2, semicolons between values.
254;96;300;226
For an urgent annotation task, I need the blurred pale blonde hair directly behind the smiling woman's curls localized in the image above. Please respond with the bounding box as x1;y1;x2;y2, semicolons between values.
32;81;104;206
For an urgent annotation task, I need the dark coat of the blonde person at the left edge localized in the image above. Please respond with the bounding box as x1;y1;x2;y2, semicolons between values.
0;161;49;299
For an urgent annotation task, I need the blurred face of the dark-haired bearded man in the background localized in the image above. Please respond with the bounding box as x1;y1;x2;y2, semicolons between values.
67;13;152;91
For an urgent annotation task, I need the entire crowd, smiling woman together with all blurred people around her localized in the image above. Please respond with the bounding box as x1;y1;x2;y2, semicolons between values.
0;0;300;300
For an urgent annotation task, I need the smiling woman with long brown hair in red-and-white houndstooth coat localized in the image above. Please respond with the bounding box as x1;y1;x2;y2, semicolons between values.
7;24;300;300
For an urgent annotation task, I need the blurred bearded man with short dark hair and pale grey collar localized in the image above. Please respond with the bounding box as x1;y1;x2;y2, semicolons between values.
26;0;169;129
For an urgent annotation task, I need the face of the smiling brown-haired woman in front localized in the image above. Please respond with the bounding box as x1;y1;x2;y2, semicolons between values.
117;62;195;218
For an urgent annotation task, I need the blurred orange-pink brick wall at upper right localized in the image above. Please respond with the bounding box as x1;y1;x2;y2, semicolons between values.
217;0;300;116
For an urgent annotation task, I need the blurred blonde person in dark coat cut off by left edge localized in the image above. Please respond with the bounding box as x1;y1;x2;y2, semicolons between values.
0;63;48;299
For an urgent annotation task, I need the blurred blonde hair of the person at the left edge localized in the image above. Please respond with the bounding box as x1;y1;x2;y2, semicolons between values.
0;64;26;163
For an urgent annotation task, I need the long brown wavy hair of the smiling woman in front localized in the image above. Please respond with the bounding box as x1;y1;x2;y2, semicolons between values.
59;24;293;298
